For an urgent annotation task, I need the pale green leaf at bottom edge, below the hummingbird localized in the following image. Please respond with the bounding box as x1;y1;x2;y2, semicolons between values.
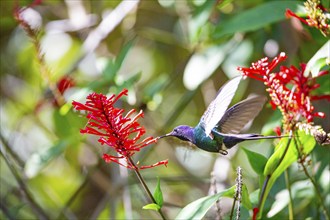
175;186;235;220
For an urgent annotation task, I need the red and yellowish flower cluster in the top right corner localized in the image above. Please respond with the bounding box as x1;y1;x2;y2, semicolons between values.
285;0;330;36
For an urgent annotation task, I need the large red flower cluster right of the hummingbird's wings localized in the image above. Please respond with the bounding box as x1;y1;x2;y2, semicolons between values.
238;53;330;130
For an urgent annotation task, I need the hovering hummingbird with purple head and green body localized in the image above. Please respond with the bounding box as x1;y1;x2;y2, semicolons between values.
159;77;283;155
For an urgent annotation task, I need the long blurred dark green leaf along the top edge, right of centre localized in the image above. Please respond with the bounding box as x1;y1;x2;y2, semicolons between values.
213;1;302;39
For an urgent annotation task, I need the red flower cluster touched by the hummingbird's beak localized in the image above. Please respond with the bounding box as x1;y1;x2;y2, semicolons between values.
72;89;168;169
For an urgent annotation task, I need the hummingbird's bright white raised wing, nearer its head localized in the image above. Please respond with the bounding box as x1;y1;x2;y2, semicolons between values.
200;77;241;135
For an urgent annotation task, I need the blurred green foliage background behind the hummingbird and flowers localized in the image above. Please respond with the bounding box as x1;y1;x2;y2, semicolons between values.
0;0;330;219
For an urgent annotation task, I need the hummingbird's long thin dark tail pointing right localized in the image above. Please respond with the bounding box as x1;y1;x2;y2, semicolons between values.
222;134;290;149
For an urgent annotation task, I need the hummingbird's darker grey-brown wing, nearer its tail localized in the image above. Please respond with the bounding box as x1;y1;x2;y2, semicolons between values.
216;96;267;134
